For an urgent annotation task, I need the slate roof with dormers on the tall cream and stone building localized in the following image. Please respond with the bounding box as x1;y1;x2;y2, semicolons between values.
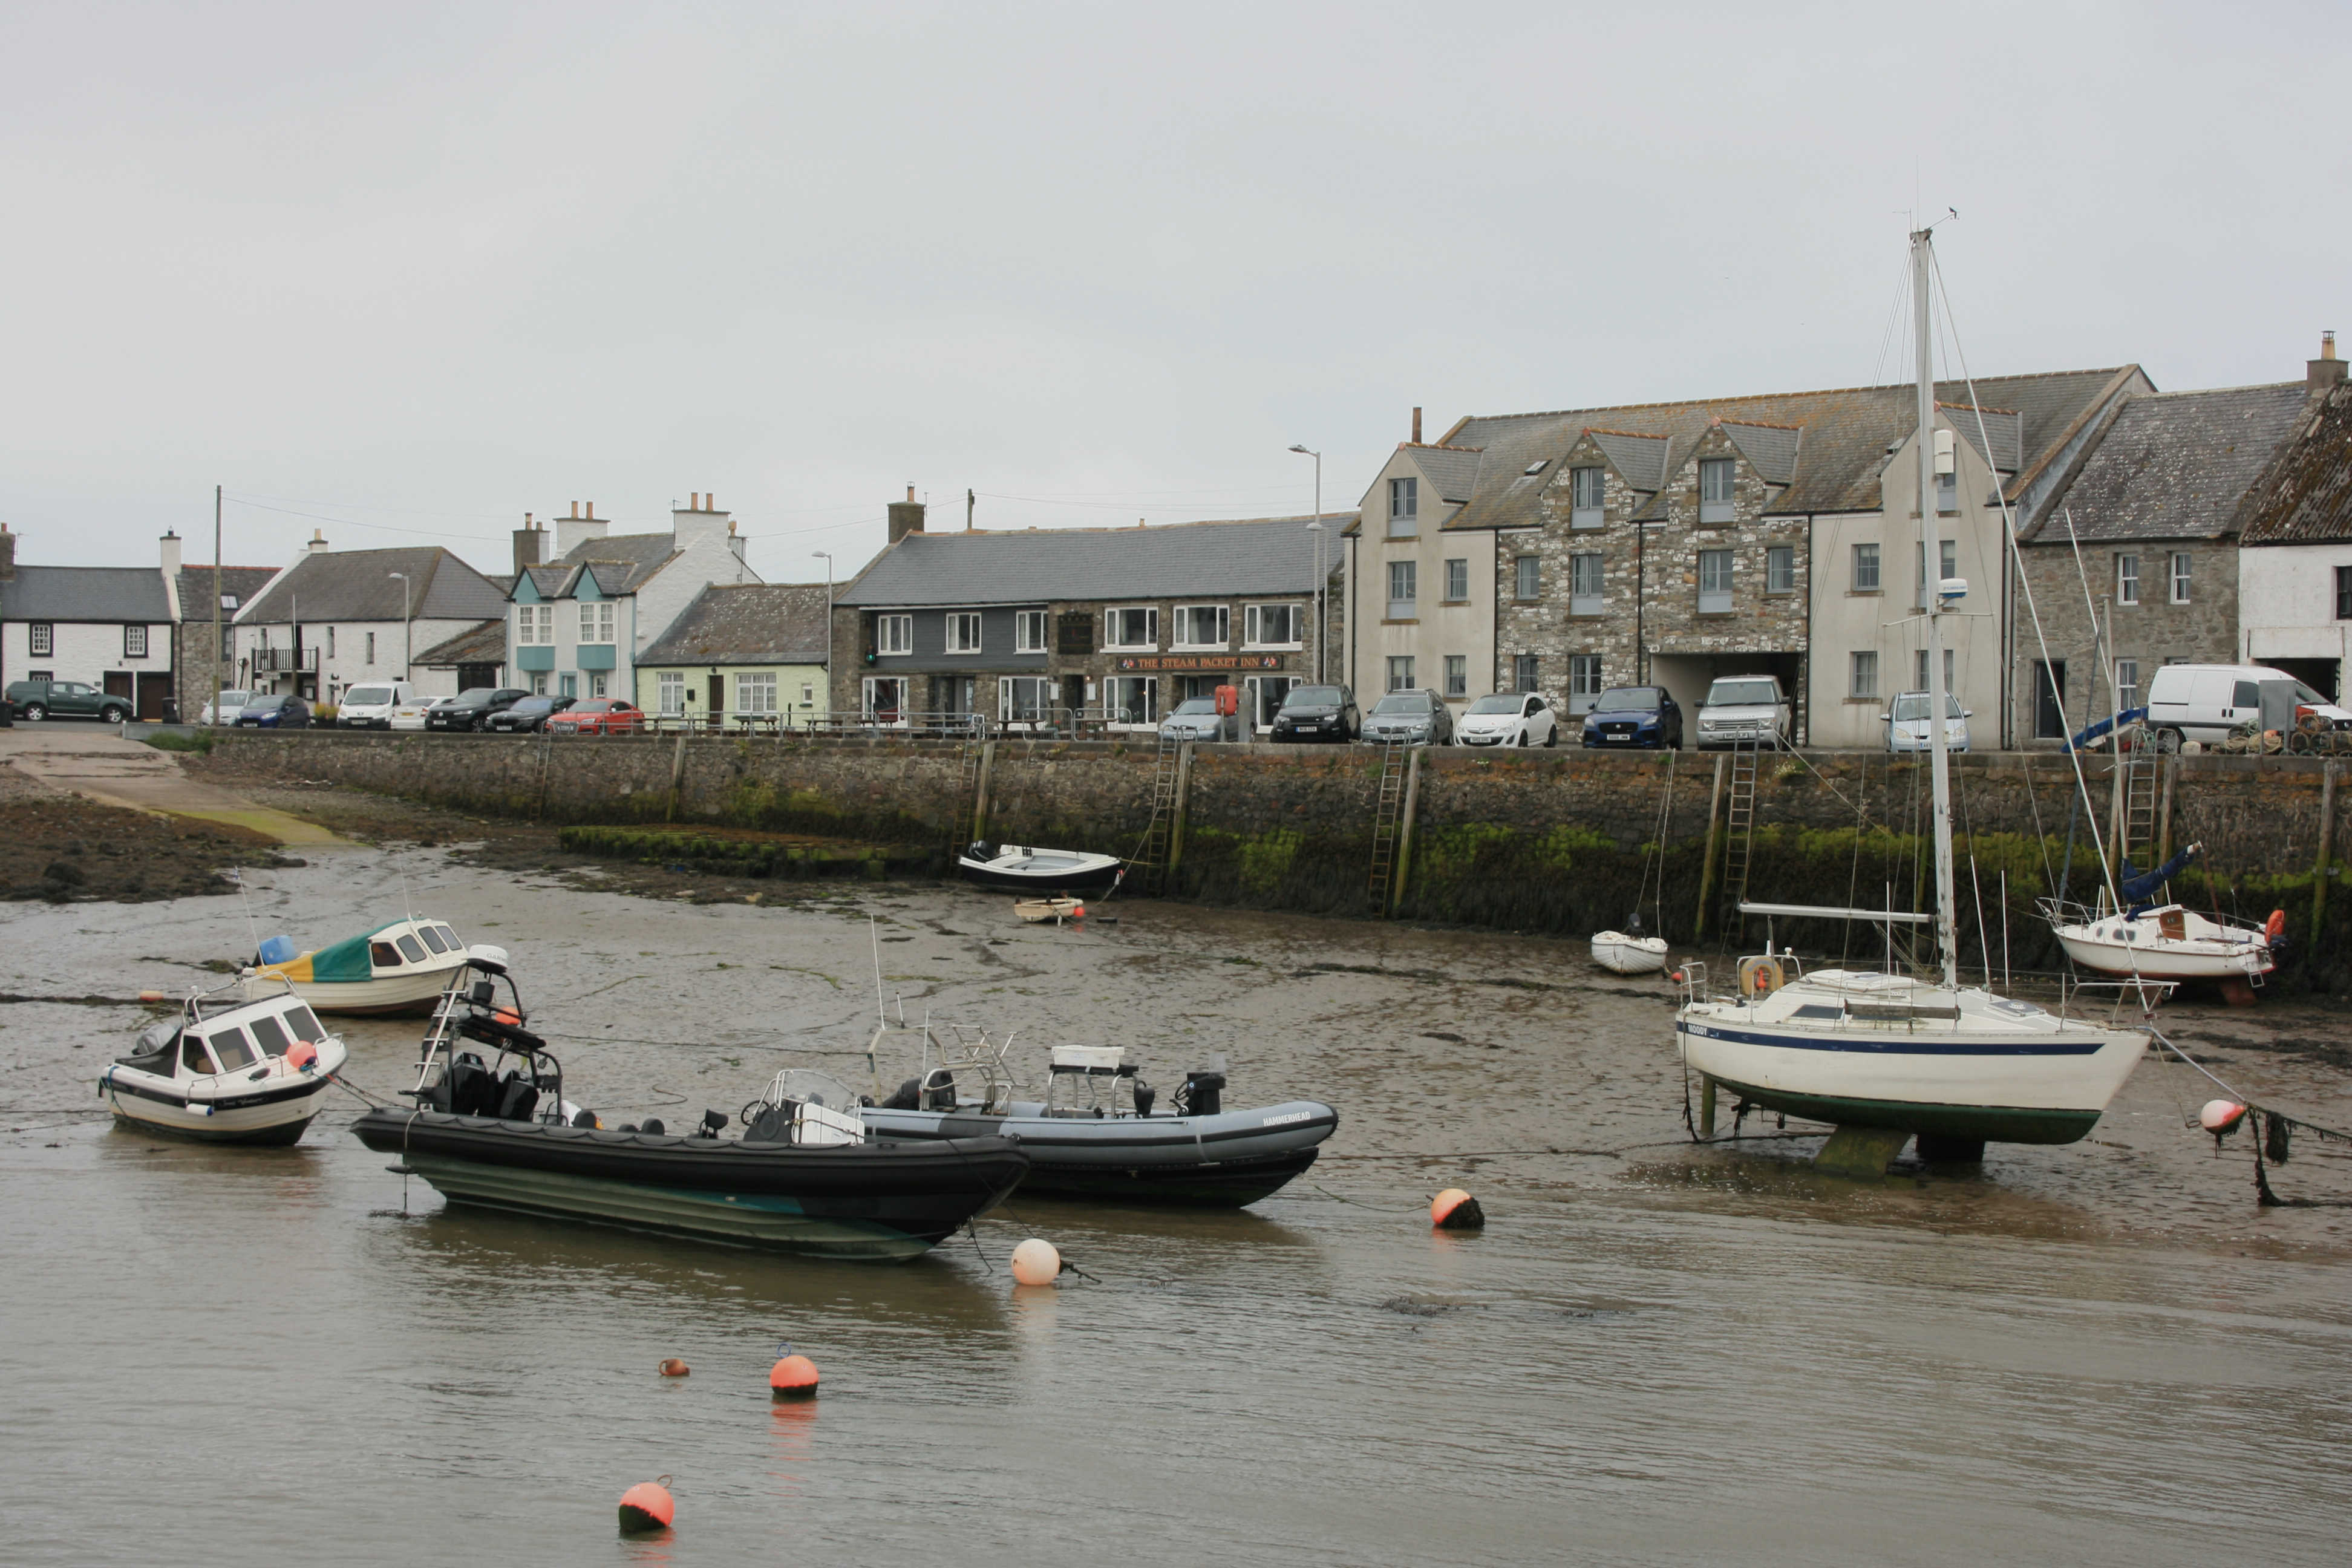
1444;364;2145;529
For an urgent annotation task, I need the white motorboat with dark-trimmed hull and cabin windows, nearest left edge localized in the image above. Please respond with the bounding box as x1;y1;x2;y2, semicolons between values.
99;980;348;1145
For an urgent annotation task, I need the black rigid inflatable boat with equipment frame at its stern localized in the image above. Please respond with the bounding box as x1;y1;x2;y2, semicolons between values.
350;947;1028;1260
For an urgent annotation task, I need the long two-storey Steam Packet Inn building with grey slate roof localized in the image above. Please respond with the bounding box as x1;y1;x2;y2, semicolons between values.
832;498;1354;731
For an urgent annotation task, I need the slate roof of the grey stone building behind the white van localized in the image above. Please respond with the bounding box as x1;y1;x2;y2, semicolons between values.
2023;381;2307;543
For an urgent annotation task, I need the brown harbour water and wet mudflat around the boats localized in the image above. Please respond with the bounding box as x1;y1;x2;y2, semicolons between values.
0;849;2352;1566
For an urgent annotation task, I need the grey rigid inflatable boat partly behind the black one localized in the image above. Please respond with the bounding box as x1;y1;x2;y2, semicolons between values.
858;1032;1338;1208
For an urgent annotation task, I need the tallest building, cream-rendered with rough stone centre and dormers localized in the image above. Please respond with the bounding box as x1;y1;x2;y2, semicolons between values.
1345;364;2154;745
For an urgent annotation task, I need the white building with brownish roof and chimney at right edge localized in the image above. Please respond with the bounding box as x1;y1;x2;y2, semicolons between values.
2236;332;2352;701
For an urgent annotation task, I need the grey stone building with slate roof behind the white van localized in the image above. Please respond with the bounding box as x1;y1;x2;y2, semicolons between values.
2008;381;2333;745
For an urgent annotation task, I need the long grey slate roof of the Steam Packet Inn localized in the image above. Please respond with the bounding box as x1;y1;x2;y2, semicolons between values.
832;510;1359;607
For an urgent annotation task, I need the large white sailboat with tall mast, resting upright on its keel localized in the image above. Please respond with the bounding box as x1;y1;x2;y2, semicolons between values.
1674;228;2148;1171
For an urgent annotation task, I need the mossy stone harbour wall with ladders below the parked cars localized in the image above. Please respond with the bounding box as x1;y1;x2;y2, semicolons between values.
191;731;2352;992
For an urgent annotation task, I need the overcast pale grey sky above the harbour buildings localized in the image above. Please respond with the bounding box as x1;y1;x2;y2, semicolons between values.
0;0;2352;581
